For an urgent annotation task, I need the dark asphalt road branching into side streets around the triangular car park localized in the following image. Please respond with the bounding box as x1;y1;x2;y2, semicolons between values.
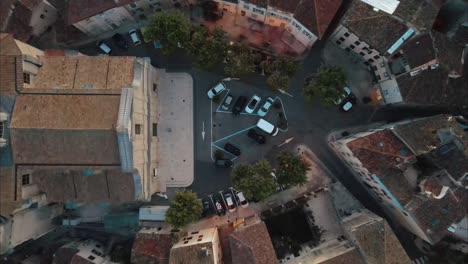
79;36;446;258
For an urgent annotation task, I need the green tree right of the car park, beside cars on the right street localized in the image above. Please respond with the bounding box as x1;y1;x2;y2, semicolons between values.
304;66;346;106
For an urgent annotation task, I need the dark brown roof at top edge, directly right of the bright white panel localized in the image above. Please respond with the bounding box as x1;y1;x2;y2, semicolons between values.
393;0;441;31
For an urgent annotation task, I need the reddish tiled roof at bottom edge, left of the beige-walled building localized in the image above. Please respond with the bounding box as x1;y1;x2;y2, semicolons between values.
131;230;178;264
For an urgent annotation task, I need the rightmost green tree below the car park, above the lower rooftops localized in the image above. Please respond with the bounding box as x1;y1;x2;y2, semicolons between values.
276;151;309;188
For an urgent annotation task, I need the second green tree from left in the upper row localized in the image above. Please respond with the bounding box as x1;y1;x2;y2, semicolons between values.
187;27;229;70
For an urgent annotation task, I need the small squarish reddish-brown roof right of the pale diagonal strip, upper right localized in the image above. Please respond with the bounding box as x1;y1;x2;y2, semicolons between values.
401;33;436;69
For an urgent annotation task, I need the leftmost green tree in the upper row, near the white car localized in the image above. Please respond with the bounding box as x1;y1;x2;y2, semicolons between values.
143;11;192;55
